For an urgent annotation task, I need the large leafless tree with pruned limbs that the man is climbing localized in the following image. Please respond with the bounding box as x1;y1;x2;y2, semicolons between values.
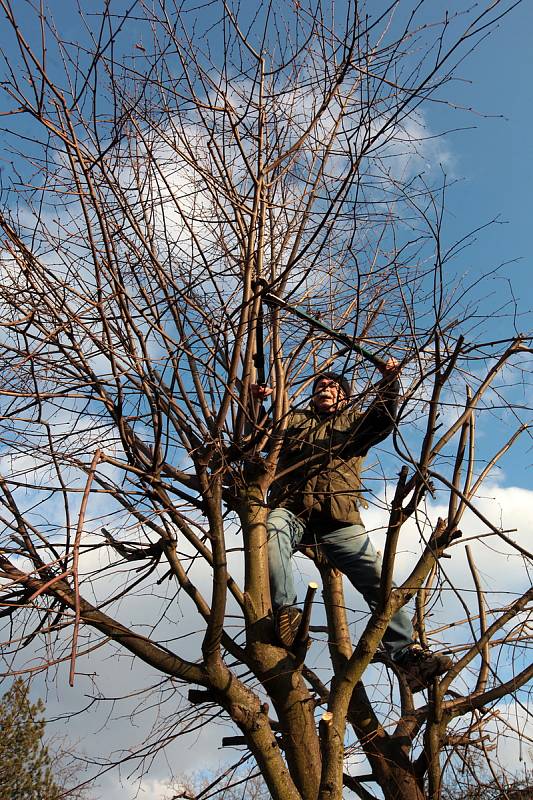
0;0;532;800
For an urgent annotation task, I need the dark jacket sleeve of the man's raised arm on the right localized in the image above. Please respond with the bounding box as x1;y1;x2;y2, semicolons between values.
344;378;400;456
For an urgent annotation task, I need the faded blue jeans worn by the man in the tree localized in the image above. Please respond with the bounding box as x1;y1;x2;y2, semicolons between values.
267;508;413;658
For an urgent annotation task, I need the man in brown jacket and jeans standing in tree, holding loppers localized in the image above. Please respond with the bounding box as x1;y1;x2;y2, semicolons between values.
252;358;452;691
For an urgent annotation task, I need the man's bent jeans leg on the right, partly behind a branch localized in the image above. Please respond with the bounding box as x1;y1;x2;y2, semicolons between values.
320;525;413;659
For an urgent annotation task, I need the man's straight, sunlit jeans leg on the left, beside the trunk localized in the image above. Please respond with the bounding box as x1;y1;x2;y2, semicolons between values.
267;508;305;609
